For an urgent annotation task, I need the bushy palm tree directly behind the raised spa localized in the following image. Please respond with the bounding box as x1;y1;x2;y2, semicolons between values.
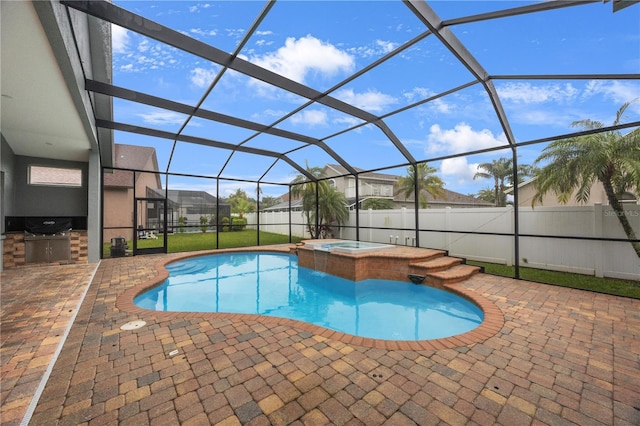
291;164;349;238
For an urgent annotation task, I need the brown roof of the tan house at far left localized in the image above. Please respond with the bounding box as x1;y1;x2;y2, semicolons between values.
104;144;162;188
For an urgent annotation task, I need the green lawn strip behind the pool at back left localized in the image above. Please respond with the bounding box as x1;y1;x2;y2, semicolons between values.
103;230;300;256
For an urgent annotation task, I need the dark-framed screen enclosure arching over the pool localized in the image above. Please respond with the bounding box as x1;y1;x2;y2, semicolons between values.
77;0;640;280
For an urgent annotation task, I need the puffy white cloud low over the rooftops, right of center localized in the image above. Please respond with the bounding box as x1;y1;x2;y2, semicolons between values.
425;123;507;154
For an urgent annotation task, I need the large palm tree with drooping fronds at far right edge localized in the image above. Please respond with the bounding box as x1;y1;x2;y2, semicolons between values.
531;102;640;258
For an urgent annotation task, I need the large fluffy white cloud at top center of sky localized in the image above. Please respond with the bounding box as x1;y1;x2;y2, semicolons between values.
250;35;355;83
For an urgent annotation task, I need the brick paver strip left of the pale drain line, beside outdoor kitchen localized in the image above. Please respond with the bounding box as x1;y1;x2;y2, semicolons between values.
0;265;96;425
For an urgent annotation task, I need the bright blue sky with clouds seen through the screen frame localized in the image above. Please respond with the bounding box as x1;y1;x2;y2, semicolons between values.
113;1;640;196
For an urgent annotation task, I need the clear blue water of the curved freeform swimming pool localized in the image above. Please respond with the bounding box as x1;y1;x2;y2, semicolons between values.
134;252;484;340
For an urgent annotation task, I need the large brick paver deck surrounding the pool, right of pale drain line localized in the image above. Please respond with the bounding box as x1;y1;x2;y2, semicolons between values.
2;246;640;426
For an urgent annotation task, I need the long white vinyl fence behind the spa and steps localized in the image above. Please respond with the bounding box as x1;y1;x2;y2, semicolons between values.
246;204;640;280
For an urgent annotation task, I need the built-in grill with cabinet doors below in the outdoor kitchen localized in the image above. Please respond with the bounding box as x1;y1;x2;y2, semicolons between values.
24;217;72;263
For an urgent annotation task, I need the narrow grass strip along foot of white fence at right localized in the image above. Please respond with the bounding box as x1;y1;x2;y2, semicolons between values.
467;261;640;299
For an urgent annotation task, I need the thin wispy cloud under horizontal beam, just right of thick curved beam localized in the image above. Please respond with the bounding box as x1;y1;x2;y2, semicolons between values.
496;83;579;104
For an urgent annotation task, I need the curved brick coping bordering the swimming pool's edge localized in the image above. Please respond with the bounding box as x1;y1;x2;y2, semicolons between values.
116;244;504;351
